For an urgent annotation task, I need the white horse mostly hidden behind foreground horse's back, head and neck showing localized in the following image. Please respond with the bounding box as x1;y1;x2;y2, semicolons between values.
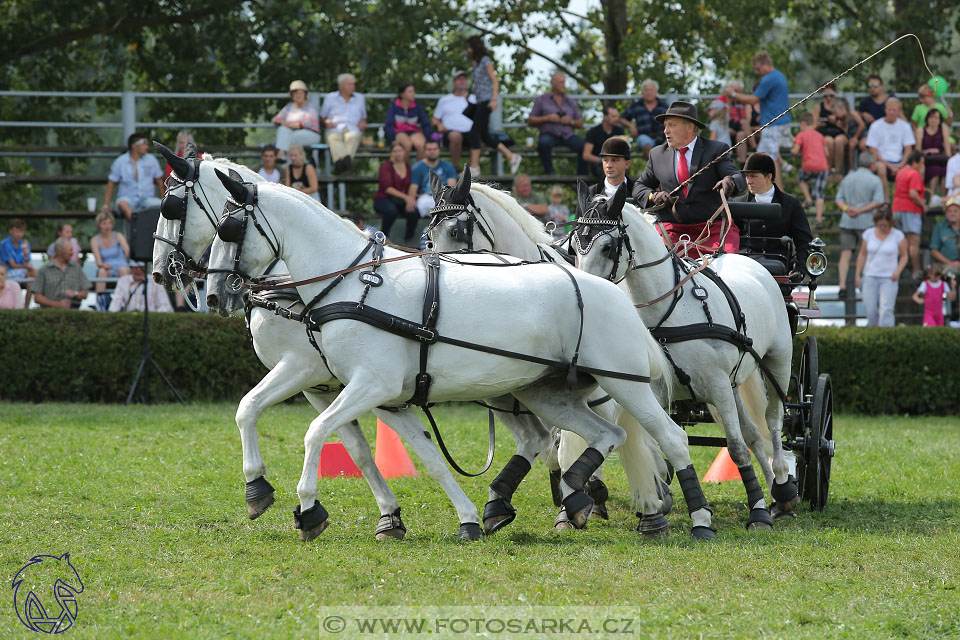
427;173;672;537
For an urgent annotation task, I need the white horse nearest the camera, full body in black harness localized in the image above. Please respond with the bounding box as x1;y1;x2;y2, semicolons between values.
207;169;716;539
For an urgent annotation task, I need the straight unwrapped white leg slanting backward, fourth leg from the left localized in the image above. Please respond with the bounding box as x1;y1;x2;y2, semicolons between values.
373;409;481;540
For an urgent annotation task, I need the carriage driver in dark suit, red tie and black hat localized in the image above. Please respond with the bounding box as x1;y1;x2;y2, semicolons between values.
633;100;746;257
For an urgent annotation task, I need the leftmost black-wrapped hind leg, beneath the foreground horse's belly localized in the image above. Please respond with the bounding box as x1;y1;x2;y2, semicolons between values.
483;404;553;535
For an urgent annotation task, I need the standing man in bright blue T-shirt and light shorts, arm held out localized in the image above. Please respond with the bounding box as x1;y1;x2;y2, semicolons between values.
726;51;790;190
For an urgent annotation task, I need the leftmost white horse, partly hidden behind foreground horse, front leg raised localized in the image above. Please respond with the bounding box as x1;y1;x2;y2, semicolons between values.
153;144;481;540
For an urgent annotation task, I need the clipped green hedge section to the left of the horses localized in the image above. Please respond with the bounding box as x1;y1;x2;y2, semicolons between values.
0;309;266;402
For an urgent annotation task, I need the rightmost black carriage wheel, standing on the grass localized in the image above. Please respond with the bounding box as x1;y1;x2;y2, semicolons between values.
798;373;834;511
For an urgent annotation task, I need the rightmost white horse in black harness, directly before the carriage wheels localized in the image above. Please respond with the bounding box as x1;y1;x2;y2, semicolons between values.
572;184;797;528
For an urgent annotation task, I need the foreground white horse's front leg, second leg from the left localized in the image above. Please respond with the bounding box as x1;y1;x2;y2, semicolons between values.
293;371;400;540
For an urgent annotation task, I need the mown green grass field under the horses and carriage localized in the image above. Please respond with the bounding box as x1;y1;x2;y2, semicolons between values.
0;403;960;638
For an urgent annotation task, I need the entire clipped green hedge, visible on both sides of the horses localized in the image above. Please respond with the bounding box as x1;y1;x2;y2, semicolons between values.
0;309;960;415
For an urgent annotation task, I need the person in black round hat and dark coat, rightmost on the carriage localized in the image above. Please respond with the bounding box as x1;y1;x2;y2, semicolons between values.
734;152;813;272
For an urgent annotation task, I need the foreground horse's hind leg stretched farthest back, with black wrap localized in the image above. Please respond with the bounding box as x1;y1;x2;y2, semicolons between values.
596;376;717;540
